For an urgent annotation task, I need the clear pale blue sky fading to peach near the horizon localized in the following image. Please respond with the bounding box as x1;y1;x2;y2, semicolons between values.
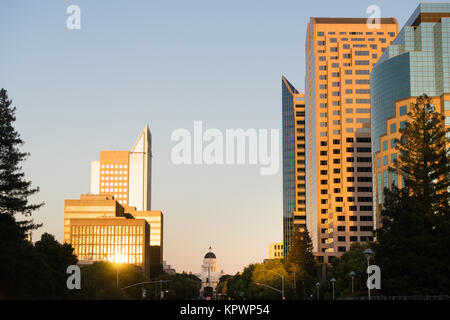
0;0;442;273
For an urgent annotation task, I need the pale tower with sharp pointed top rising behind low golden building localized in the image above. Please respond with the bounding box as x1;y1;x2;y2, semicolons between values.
91;126;152;211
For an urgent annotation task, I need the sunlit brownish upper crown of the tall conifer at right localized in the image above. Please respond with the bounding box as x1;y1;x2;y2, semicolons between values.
391;95;450;215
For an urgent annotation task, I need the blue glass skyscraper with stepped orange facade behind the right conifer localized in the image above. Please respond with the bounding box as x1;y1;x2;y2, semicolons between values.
371;3;450;228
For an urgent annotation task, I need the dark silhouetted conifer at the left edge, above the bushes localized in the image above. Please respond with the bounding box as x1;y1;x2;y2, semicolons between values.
0;89;43;235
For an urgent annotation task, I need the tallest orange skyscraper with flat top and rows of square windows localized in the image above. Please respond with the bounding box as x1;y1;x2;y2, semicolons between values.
305;18;398;263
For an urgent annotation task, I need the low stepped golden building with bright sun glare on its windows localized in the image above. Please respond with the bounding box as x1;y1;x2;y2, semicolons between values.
64;195;151;276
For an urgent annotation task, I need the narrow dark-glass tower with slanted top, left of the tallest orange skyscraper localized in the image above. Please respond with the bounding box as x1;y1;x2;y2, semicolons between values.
281;77;306;257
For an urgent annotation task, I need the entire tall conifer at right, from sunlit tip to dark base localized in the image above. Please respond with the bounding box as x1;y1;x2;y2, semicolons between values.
375;95;450;295
